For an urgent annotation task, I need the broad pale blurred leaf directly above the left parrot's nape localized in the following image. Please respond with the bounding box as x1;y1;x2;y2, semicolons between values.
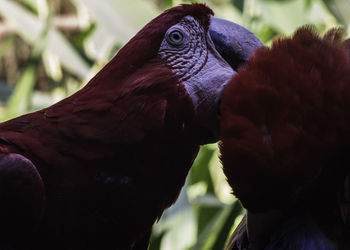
74;0;160;60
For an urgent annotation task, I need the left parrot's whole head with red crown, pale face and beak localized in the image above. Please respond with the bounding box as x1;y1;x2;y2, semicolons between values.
84;4;262;144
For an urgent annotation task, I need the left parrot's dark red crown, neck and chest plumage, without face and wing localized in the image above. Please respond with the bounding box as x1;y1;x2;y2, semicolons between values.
0;4;212;250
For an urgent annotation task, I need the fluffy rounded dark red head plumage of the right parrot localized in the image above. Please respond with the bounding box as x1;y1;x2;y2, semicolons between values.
221;27;350;211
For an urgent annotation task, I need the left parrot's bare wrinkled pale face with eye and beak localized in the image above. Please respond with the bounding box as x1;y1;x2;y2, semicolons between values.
158;12;262;143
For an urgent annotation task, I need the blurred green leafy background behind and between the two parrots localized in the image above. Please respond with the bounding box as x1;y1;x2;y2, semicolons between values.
0;0;350;250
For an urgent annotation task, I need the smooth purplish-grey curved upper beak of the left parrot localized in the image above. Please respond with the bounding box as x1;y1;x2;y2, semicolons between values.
209;17;264;71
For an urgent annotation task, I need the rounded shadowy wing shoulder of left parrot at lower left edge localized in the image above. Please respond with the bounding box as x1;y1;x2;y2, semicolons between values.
0;146;45;249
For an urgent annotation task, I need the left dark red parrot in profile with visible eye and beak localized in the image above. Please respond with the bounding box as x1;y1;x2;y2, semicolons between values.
0;4;262;250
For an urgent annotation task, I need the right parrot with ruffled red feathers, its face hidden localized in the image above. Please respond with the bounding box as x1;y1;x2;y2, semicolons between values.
220;26;350;250
